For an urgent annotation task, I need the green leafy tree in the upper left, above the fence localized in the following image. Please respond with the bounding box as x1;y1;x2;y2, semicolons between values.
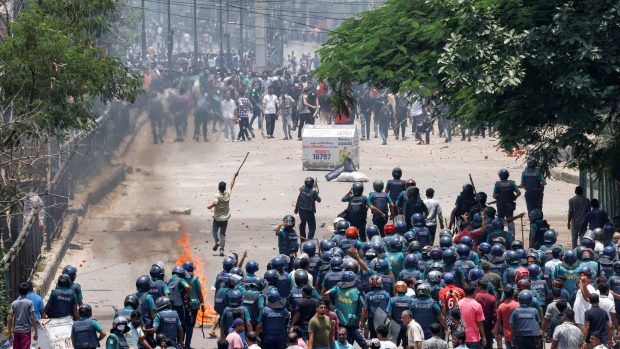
0;0;141;148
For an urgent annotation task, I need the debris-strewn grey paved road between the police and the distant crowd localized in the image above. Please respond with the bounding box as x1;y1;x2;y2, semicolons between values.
49;113;572;348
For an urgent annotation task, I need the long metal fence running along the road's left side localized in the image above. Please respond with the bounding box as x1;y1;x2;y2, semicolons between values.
0;103;133;299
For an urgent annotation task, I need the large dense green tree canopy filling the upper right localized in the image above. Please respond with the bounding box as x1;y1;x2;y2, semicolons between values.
317;0;620;174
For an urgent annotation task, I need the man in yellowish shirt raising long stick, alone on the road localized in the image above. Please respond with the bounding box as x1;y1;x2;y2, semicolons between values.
207;152;250;256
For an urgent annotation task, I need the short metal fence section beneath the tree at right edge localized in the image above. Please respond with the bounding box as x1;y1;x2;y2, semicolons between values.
579;171;620;219
